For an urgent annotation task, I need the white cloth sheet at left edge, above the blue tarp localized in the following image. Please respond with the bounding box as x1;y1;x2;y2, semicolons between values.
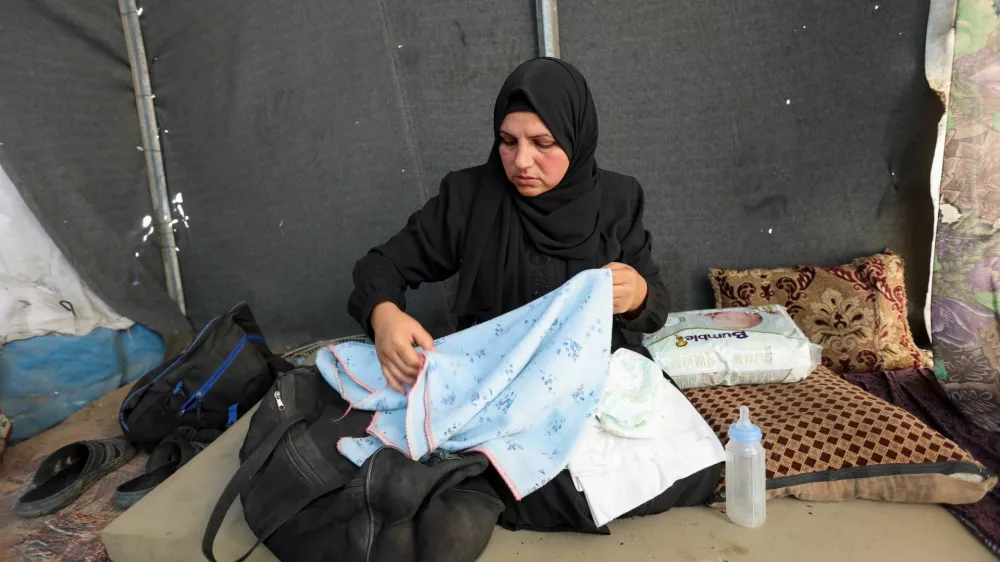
0;160;132;340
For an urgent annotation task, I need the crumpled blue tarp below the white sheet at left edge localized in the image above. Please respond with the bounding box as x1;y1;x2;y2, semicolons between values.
0;324;166;441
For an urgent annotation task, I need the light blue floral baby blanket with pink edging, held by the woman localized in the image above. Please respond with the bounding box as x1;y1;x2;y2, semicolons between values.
316;270;612;500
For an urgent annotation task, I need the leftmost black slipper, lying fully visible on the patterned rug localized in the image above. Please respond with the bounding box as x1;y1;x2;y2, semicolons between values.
14;437;136;517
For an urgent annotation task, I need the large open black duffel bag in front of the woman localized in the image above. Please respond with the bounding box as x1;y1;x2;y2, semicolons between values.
202;367;503;562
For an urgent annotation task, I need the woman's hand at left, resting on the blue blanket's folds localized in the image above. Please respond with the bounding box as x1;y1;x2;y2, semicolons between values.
371;302;434;393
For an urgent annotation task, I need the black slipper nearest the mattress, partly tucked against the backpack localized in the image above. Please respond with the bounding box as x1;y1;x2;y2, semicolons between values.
115;427;222;509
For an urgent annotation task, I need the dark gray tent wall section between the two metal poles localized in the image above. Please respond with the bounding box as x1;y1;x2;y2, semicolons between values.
143;0;535;344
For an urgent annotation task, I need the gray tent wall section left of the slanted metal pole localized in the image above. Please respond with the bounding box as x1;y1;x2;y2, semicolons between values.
0;0;191;338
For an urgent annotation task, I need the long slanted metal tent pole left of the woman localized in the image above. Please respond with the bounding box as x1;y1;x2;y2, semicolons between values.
118;0;187;315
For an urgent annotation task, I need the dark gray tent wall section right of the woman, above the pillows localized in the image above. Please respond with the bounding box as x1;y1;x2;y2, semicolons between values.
559;0;944;343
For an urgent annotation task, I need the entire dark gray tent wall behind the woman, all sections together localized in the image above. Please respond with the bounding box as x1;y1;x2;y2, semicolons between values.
0;0;941;346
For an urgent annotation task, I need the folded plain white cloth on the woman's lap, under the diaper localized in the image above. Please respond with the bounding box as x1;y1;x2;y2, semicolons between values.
569;350;726;526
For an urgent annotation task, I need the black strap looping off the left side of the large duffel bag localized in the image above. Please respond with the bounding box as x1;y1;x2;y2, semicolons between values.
201;414;350;562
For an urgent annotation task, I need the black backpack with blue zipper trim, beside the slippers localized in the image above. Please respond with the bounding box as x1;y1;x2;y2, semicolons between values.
119;303;292;452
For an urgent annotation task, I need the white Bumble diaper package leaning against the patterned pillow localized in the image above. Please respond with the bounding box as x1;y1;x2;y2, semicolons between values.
643;305;823;388
